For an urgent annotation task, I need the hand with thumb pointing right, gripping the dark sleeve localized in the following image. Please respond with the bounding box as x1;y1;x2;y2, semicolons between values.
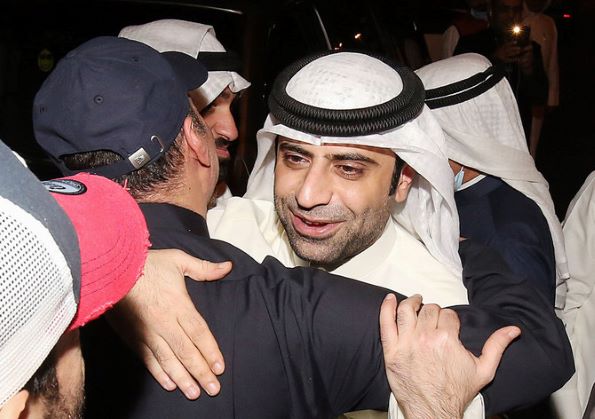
380;294;521;419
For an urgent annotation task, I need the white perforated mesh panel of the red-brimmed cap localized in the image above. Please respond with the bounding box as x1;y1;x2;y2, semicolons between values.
0;196;77;408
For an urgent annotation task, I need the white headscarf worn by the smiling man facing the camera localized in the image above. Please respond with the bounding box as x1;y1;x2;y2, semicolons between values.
245;52;461;276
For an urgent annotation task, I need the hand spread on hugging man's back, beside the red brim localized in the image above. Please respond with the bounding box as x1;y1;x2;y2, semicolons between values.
108;250;231;399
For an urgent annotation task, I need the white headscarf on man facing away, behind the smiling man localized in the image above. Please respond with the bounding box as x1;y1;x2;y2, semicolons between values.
416;54;569;308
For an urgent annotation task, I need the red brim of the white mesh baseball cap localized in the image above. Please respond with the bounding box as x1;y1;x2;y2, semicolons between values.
43;173;150;330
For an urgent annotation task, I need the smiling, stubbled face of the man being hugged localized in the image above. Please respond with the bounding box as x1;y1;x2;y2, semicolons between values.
275;137;395;269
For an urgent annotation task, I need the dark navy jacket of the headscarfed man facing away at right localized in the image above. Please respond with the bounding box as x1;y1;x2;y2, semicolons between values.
455;176;556;305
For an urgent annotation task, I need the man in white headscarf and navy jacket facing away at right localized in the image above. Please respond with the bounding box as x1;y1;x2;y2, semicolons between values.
417;54;569;308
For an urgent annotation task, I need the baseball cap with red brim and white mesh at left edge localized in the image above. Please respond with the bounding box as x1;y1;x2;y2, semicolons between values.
0;142;149;407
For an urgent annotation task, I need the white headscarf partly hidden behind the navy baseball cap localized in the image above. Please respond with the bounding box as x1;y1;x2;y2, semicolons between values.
118;19;250;109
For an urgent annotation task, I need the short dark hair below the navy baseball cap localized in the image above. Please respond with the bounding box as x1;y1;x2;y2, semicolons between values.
62;109;207;200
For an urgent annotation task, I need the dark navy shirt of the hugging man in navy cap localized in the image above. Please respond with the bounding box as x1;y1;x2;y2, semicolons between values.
83;204;573;419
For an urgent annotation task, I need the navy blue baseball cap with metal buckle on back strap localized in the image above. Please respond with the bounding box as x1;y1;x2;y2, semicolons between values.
33;36;208;178
